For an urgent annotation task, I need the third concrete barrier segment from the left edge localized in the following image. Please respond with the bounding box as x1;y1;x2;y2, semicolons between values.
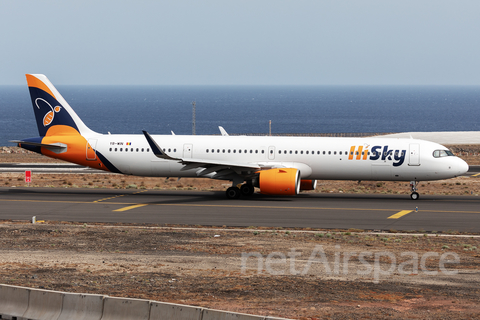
57;293;104;320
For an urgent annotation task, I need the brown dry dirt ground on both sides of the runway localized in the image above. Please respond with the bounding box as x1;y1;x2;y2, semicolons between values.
0;146;480;319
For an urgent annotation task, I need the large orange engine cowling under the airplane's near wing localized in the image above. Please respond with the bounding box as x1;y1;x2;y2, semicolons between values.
258;168;300;195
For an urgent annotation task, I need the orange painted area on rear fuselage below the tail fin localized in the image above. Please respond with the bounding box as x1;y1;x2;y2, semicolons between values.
42;125;109;171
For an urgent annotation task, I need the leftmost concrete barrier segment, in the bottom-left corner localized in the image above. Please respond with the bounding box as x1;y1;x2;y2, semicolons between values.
0;284;30;319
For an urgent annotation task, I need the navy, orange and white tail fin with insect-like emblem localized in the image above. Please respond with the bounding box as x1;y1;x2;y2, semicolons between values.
26;74;95;137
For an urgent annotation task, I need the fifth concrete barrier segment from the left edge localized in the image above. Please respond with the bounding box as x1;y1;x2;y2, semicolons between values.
150;301;203;320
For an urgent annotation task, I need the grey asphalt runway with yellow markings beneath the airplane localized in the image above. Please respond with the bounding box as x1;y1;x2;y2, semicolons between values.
0;188;480;232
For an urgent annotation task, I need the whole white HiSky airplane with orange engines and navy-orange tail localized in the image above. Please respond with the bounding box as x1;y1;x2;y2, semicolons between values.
13;74;468;200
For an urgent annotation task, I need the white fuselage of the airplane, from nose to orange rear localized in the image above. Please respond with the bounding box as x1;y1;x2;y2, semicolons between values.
88;135;468;181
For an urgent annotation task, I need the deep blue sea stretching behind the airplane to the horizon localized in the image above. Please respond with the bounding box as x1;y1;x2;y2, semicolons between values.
0;85;480;146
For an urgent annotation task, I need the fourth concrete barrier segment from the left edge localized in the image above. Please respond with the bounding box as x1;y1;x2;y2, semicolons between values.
102;297;150;320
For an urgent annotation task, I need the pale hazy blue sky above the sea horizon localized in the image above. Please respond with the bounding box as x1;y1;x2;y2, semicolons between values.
0;0;480;85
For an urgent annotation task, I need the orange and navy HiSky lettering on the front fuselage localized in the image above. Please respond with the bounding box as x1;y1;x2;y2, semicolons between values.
348;145;407;167
